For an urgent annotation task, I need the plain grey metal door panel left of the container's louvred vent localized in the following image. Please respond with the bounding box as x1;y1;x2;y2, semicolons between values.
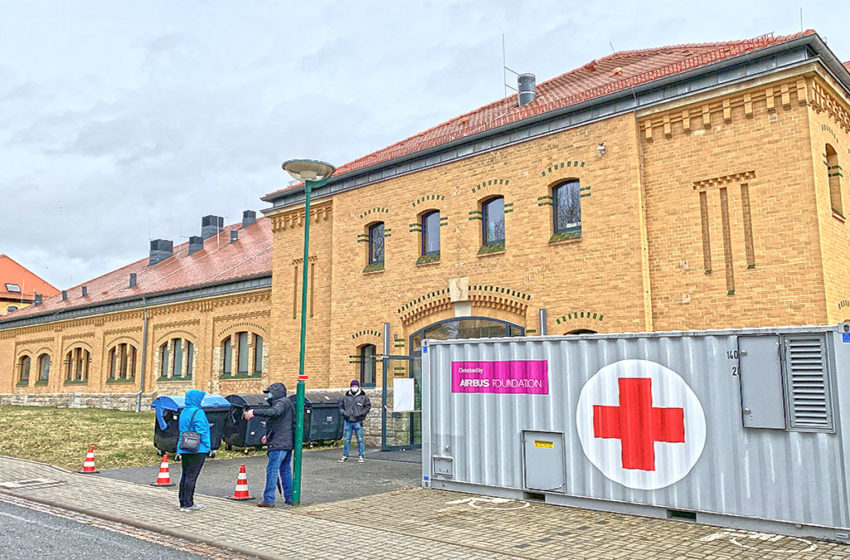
738;336;785;430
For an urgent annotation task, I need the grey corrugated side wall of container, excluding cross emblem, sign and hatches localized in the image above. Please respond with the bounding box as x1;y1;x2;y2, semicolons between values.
422;327;850;528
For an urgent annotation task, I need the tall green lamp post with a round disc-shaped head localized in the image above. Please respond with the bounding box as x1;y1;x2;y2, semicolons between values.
282;159;336;505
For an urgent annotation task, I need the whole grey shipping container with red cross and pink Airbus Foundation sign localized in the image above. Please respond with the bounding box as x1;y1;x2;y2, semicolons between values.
422;323;850;542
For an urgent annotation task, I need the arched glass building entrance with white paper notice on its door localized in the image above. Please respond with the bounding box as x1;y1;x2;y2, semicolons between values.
381;317;525;450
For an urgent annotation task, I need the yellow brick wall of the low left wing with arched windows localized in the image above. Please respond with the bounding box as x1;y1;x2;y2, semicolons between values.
0;290;271;395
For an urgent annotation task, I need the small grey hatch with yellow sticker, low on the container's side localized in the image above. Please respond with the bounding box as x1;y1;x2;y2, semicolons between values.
522;431;565;492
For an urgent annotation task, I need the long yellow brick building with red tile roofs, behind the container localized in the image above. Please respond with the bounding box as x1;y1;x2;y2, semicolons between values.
0;31;850;446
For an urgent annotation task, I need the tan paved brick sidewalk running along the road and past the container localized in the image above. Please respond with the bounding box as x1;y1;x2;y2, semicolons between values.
0;457;850;560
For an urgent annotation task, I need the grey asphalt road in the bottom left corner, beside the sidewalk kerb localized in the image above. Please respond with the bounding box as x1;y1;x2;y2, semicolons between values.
0;501;203;560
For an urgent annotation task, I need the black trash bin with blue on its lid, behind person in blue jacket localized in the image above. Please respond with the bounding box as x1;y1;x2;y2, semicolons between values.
151;394;230;460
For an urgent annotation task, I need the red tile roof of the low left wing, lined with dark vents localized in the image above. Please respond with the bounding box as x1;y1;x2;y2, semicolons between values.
0;218;272;322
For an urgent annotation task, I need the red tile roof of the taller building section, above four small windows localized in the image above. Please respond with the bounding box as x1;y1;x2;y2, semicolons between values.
266;30;815;197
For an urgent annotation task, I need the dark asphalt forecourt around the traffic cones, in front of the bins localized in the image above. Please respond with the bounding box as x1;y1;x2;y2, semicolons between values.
100;449;422;505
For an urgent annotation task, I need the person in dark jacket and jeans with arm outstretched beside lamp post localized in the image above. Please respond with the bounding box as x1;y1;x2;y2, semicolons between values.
244;383;295;507
